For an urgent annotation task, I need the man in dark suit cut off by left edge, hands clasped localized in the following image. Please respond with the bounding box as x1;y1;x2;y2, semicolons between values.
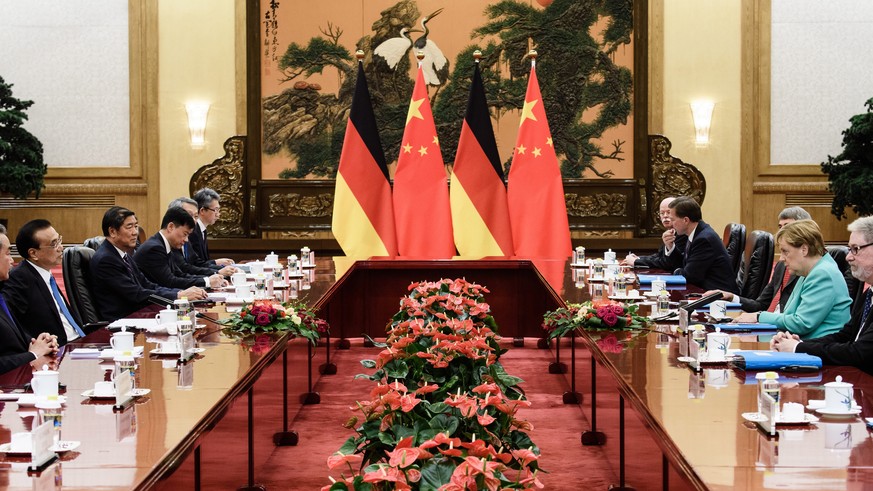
0;225;58;373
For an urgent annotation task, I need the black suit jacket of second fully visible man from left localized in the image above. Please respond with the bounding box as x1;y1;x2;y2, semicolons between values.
90;240;179;321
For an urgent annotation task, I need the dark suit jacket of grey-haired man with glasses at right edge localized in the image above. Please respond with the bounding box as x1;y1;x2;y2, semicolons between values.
794;288;873;374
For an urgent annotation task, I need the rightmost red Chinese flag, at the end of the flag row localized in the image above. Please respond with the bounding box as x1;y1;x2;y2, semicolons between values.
507;66;571;258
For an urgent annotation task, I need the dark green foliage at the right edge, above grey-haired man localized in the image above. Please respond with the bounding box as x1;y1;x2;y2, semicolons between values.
821;98;873;220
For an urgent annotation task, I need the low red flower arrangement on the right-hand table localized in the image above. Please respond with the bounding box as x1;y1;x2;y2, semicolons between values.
543;301;649;339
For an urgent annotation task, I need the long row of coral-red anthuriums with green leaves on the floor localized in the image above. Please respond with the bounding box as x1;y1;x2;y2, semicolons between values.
322;279;543;491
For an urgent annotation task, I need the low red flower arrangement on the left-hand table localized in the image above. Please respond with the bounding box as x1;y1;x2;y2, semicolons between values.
222;299;329;344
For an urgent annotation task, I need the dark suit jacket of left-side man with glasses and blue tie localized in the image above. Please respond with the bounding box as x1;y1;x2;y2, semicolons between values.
3;261;76;346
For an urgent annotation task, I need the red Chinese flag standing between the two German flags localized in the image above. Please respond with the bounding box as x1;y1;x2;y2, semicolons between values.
394;66;455;258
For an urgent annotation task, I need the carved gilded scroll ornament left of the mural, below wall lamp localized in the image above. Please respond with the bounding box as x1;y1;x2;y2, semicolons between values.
188;136;246;237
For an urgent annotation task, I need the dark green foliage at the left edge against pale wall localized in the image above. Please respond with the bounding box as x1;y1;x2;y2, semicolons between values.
0;77;48;199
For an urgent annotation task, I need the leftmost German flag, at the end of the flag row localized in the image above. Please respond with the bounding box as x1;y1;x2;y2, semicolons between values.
331;61;397;258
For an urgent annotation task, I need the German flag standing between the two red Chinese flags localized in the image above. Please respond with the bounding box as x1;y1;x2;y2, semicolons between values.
450;63;513;256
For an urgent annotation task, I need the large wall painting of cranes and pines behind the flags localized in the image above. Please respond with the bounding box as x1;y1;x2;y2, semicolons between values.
261;0;633;179
